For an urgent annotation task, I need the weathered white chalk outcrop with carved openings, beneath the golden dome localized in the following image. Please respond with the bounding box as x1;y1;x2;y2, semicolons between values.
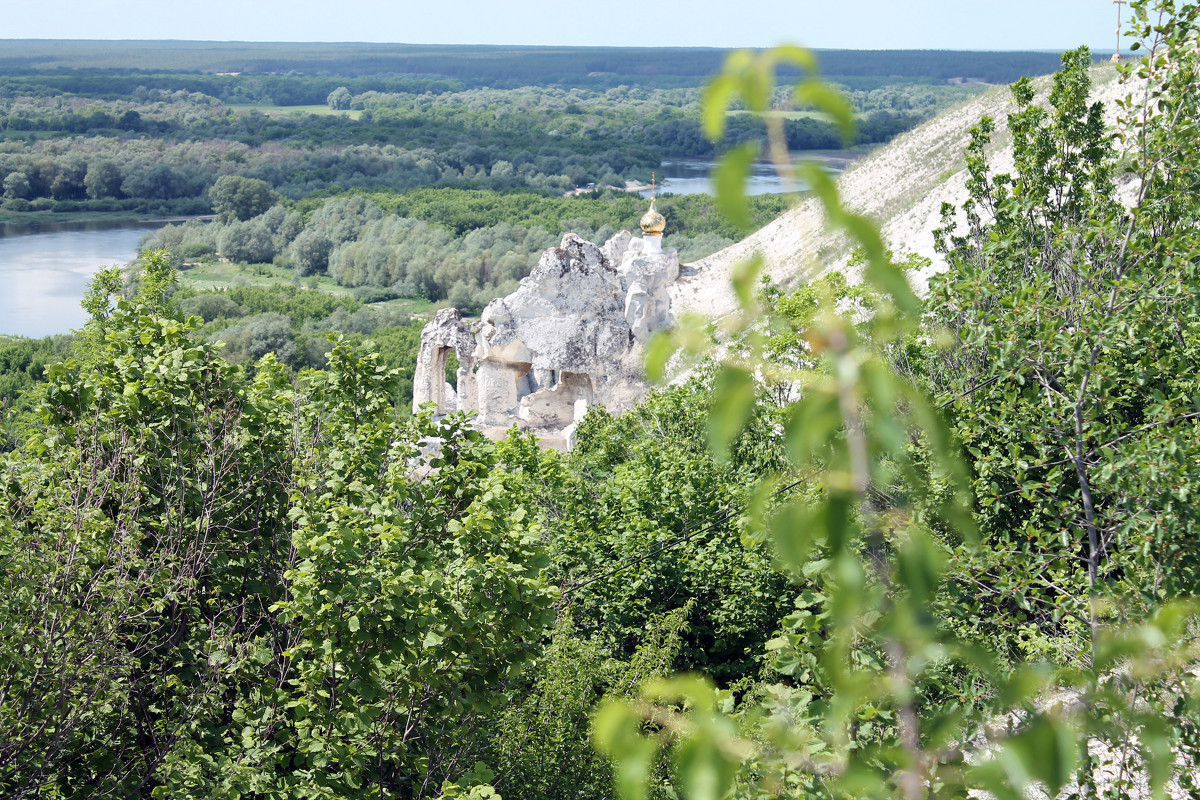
413;231;679;449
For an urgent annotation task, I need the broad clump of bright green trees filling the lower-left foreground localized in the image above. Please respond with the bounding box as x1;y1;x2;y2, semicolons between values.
0;255;550;798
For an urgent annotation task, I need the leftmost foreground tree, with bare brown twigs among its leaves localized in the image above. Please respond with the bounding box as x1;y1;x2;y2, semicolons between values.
0;309;288;798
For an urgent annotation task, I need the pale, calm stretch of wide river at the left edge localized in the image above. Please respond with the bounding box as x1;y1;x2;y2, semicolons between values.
0;221;162;337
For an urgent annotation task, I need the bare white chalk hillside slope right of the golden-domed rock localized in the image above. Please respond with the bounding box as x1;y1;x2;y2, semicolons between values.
672;65;1128;317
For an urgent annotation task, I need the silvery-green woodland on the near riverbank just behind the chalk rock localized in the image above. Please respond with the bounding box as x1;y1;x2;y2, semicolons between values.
143;188;791;313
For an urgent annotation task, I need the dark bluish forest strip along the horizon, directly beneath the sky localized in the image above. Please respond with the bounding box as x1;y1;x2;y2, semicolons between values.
0;40;1080;89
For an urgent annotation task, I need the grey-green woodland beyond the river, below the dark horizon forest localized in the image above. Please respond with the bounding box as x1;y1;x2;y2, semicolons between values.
0;78;960;213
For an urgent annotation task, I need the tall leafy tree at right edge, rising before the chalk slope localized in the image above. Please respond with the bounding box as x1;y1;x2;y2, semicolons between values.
932;42;1200;642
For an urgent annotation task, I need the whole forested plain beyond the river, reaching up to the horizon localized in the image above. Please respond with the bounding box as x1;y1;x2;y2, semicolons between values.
0;42;1054;215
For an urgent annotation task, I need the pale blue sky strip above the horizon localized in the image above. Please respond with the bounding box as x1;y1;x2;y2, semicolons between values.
0;0;1117;50
